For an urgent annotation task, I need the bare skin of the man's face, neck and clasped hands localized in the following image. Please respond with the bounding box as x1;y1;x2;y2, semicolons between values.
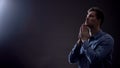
78;11;101;43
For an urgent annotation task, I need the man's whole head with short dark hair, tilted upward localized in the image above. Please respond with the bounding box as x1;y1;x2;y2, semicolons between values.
85;7;104;27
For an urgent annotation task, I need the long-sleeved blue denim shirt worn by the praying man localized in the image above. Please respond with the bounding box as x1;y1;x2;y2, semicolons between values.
68;30;114;68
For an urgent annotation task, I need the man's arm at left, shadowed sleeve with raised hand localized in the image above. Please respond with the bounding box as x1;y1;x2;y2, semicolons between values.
68;24;90;63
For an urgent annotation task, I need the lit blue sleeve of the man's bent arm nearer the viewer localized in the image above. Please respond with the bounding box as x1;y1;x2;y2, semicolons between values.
82;37;114;63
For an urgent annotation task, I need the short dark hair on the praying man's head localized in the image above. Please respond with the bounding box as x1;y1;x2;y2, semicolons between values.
88;7;104;26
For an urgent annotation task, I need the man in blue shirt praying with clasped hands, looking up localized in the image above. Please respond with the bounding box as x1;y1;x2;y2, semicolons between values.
68;7;114;68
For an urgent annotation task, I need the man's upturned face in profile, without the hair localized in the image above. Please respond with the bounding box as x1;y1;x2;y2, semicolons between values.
85;11;98;27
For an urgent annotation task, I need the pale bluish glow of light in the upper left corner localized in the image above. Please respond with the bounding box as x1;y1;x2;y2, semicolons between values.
0;0;28;41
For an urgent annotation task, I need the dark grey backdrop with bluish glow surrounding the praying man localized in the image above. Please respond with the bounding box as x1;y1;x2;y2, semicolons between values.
0;0;120;68
